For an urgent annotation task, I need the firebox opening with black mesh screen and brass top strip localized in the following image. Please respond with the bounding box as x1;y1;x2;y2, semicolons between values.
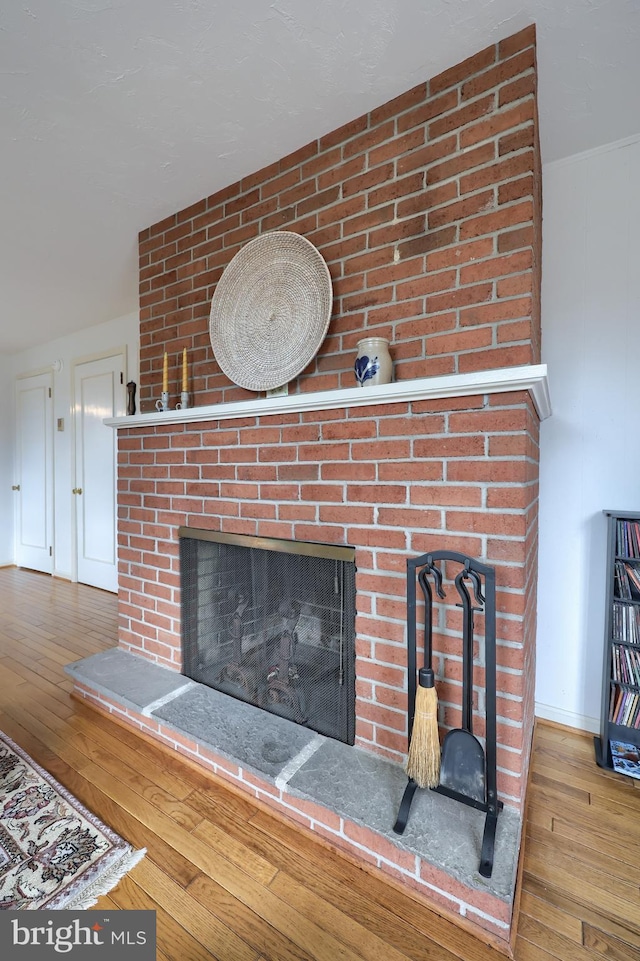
179;527;355;744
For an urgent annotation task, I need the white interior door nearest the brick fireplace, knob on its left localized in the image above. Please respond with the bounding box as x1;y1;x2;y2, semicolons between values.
74;353;125;593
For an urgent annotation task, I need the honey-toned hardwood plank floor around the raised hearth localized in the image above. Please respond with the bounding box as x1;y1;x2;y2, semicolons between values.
0;568;640;961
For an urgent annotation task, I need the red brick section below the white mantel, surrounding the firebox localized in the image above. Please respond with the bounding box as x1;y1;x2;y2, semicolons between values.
119;393;538;803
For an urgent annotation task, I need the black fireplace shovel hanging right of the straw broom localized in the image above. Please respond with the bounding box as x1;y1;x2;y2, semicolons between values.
440;570;487;804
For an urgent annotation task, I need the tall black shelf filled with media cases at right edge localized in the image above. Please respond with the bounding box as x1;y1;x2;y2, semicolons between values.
594;511;640;770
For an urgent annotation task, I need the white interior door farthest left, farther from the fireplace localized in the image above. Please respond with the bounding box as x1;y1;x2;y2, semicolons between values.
14;372;53;574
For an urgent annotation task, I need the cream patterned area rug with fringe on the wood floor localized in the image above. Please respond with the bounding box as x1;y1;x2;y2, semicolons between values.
0;732;145;911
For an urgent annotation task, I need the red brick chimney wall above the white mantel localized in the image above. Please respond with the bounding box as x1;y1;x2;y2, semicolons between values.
139;27;541;411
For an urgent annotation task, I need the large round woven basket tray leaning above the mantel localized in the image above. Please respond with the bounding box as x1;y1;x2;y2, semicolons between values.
209;230;333;390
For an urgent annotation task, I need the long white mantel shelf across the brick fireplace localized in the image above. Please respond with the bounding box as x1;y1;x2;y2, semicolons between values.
104;364;551;429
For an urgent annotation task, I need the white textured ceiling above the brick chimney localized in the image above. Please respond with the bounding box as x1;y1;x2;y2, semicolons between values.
0;0;640;353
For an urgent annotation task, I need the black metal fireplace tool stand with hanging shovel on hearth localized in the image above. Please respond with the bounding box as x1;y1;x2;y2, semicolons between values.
393;551;503;878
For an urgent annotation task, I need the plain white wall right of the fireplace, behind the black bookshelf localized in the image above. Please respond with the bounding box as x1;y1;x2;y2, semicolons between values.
536;137;640;731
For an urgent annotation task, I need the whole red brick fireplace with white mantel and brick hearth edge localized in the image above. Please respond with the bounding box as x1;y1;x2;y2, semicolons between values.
74;27;548;942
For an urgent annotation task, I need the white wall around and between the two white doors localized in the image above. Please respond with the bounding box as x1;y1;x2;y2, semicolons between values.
7;311;139;578
